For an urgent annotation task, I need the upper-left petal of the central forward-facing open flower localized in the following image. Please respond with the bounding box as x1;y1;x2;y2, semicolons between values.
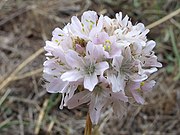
65;50;84;69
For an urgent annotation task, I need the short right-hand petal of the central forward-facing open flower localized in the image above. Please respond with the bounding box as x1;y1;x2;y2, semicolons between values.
95;62;109;75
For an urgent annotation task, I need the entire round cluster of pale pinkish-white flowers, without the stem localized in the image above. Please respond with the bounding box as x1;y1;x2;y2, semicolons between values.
44;11;162;124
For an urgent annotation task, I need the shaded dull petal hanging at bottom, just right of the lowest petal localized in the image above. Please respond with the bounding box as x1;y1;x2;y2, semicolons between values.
112;100;127;119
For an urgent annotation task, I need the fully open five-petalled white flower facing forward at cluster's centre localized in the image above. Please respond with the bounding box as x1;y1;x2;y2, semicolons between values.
61;44;109;91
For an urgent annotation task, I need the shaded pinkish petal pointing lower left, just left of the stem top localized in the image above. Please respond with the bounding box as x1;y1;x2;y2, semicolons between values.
66;90;91;109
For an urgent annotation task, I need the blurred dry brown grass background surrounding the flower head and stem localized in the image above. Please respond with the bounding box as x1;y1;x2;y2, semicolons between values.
0;0;180;135
